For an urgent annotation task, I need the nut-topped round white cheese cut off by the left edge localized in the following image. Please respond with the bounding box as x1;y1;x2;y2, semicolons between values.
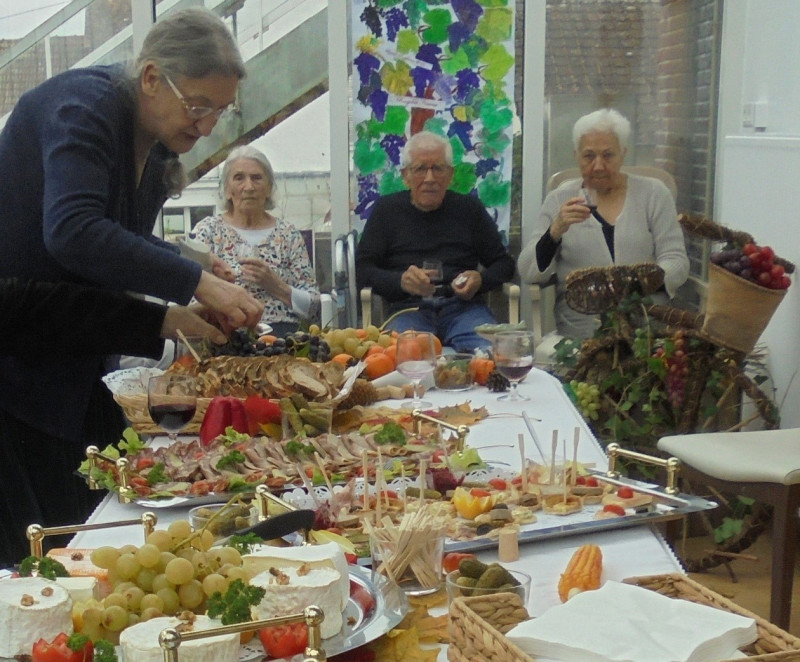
0;577;72;657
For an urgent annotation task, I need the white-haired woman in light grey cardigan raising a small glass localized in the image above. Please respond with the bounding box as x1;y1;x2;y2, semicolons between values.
518;109;689;339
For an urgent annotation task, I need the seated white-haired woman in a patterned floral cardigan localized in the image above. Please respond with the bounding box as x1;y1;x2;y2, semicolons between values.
193;145;320;336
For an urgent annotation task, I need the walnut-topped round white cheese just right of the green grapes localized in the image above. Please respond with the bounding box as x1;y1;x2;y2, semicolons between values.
250;567;342;639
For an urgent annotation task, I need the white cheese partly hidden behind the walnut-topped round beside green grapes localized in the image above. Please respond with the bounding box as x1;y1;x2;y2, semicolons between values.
242;542;350;618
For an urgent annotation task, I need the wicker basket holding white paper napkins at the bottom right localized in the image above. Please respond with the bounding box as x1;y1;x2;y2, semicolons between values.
447;573;800;662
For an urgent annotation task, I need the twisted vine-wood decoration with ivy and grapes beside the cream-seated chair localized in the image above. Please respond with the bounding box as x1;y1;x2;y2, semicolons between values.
556;214;794;569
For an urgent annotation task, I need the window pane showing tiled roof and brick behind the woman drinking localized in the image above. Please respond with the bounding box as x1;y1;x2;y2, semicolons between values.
545;0;720;215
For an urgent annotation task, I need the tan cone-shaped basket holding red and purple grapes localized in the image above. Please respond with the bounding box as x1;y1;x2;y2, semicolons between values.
703;264;786;353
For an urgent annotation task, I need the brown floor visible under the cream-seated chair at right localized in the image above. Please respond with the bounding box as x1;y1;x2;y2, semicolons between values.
676;533;800;636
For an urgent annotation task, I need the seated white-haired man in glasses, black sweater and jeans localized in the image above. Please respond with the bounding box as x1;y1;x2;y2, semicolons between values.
356;131;514;352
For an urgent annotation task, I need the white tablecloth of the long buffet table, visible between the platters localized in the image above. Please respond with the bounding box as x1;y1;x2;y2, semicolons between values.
70;369;683;660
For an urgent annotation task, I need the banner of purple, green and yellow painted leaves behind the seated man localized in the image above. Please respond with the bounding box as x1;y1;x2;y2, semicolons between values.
352;0;514;237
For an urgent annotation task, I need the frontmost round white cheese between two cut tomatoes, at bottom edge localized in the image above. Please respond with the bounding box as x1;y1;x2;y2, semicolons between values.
119;616;240;662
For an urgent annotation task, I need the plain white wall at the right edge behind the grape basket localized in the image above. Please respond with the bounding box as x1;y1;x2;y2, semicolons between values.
715;0;800;428
